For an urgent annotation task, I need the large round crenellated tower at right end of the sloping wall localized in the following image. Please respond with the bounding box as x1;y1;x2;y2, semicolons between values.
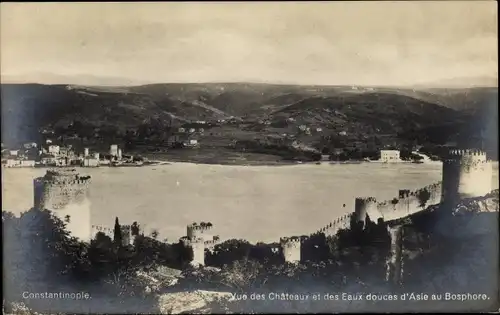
442;150;493;203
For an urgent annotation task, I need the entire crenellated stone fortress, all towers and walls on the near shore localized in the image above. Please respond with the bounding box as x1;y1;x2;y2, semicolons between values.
34;150;493;278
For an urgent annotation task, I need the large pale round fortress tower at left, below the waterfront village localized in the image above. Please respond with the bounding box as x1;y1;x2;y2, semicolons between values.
33;169;92;241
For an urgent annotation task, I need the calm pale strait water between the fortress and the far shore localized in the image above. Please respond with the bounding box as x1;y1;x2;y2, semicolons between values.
2;163;498;241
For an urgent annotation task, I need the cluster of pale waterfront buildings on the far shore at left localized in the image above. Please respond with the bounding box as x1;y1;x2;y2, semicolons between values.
2;140;147;168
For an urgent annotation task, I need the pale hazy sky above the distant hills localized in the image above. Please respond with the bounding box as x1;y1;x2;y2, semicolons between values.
0;1;498;85
